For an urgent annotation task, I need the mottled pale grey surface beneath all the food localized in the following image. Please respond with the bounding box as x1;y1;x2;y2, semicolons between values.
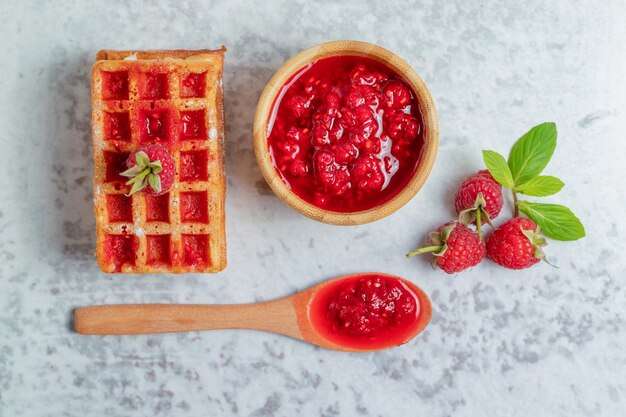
0;0;626;417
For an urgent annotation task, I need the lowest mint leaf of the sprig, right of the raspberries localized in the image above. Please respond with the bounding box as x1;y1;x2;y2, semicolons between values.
517;200;585;240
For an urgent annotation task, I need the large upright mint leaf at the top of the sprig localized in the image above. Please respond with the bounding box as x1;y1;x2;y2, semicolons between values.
509;123;556;185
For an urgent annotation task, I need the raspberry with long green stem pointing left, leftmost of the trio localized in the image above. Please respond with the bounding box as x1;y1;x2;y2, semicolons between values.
406;222;485;274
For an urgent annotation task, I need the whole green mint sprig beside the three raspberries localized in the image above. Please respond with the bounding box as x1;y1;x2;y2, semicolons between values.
483;123;585;240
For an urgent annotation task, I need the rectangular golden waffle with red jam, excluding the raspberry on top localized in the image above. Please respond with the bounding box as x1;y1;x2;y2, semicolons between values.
91;47;226;273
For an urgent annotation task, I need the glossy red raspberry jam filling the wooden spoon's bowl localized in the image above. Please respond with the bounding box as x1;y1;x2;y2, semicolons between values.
309;274;420;350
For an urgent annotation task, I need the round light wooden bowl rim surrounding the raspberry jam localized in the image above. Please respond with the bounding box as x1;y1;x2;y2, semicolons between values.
253;41;439;225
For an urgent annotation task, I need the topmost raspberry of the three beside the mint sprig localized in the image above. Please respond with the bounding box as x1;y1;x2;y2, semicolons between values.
454;170;503;228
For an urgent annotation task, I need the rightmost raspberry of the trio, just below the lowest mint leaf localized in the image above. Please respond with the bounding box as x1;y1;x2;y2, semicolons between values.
487;217;546;269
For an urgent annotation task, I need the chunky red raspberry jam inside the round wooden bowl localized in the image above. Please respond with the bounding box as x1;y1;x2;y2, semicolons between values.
268;56;423;212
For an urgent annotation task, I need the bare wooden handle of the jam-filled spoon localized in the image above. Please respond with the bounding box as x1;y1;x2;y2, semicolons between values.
74;298;302;339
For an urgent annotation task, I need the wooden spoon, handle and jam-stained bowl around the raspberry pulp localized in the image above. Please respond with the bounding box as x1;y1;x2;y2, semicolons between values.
74;273;432;352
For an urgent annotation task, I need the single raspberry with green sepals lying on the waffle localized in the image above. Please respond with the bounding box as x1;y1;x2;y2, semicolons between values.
120;144;176;195
